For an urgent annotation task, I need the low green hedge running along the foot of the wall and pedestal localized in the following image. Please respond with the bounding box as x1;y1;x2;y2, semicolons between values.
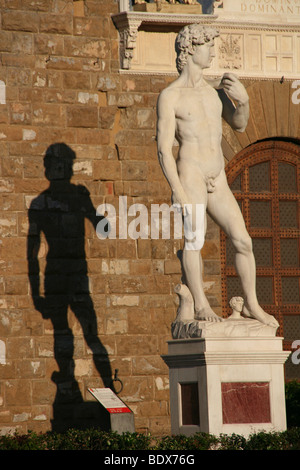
0;428;300;451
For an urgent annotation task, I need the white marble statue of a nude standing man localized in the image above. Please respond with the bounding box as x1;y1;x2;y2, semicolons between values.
157;24;278;327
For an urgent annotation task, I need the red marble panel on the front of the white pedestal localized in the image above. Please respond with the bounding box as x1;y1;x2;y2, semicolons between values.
222;382;271;424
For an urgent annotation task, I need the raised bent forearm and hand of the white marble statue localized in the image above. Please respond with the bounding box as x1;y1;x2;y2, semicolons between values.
218;73;249;132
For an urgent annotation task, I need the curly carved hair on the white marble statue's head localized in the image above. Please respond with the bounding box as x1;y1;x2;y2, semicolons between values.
175;23;219;73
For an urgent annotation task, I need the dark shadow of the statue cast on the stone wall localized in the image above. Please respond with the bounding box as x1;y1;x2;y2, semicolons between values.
27;143;113;431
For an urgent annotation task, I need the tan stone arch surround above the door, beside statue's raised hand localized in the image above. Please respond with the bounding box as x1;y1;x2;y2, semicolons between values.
222;80;300;163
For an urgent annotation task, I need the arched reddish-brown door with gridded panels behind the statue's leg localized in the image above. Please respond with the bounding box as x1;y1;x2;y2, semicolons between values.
221;141;300;379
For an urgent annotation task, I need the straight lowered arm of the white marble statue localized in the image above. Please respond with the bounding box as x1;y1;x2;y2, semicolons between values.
157;90;188;207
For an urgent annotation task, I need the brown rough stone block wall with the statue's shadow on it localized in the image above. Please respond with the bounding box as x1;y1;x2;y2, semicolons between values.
0;0;221;434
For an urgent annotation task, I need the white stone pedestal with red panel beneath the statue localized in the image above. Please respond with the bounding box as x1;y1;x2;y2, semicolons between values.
163;319;290;437
